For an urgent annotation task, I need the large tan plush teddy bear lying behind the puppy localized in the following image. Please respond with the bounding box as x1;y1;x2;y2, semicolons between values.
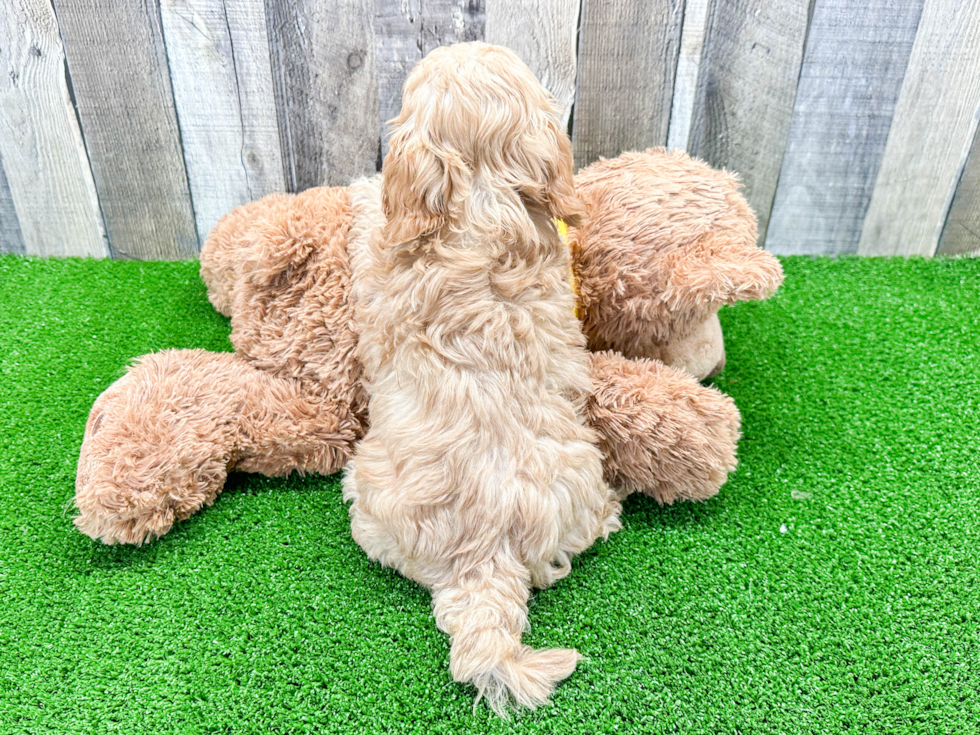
75;149;782;544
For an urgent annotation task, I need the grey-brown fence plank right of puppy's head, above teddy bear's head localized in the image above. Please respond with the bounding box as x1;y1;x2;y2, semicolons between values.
572;0;684;166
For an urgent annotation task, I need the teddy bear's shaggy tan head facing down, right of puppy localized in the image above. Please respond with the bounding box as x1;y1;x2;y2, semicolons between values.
569;148;783;380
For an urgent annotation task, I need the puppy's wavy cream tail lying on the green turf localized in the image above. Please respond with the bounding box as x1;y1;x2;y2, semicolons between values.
433;556;580;717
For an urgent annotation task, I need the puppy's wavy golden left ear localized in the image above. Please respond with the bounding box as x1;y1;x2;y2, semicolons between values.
381;130;468;244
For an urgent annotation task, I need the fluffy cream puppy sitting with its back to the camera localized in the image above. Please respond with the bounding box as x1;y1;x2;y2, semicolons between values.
344;43;620;713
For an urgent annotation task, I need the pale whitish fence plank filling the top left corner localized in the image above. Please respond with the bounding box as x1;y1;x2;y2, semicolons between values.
0;0;108;258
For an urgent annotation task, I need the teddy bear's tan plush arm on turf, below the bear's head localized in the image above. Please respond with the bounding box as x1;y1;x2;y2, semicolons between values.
586;352;740;505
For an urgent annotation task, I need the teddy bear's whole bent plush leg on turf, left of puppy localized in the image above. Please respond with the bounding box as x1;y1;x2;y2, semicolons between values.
75;350;361;544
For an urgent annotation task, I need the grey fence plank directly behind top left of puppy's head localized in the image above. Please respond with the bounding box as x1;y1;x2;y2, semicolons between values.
374;0;486;154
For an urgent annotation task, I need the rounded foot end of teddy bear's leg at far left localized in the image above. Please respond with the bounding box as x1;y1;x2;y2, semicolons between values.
74;350;234;544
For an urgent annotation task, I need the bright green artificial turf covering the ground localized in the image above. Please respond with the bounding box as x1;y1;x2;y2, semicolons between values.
0;256;980;734
